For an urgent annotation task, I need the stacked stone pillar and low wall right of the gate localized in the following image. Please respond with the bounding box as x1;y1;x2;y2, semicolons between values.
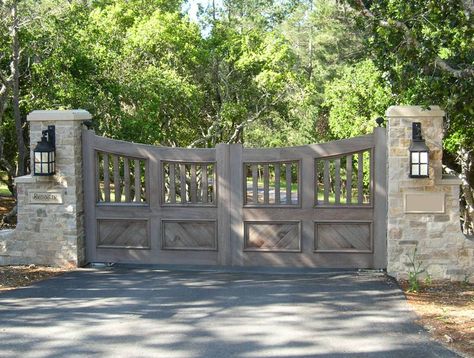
386;106;474;280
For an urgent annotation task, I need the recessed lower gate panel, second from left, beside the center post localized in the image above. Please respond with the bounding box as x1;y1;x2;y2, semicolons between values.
161;220;217;250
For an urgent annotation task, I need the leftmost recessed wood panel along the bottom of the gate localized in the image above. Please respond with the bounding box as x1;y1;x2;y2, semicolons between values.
97;219;150;249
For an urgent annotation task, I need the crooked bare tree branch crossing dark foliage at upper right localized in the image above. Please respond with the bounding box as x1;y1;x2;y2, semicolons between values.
355;0;474;78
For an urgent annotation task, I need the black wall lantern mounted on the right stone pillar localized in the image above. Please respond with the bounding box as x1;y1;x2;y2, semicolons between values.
410;122;430;178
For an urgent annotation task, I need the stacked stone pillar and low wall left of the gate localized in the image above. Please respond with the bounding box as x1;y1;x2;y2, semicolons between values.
0;110;91;266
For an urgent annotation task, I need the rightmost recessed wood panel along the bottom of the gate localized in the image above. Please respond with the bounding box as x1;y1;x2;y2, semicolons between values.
314;222;372;252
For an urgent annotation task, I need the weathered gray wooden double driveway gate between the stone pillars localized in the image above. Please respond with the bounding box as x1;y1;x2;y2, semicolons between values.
83;128;387;268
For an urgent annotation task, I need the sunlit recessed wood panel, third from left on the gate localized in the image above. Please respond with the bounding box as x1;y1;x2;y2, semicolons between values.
245;221;301;252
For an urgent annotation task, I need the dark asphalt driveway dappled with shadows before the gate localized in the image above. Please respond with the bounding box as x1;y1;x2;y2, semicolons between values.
0;268;457;358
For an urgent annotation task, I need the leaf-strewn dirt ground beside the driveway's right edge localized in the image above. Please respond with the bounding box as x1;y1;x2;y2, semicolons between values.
400;282;474;357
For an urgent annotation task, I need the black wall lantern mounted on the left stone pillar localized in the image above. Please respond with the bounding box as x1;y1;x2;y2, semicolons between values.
33;126;56;175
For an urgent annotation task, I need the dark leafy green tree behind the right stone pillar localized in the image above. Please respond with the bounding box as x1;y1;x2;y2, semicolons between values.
348;0;474;233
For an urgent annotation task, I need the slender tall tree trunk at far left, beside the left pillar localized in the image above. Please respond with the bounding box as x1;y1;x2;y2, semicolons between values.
11;1;26;176
